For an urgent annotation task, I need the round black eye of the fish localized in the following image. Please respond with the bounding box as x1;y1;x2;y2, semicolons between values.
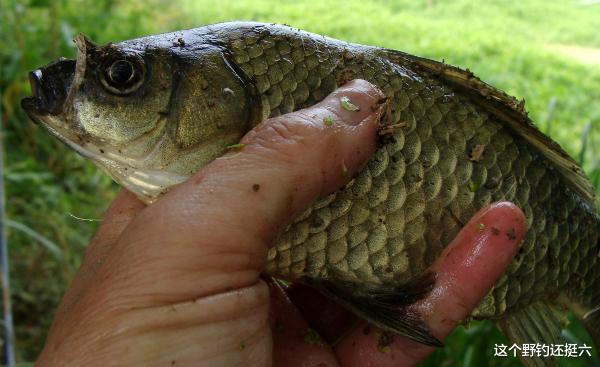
100;57;146;95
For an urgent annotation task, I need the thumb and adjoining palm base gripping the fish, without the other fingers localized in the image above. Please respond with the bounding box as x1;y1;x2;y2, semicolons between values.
40;81;383;366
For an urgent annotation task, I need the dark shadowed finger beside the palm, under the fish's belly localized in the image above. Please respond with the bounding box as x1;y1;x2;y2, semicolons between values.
269;282;338;367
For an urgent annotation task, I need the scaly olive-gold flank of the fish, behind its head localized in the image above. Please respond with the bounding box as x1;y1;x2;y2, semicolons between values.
218;25;597;317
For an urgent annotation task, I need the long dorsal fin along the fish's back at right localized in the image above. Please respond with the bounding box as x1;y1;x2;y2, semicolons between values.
384;50;596;208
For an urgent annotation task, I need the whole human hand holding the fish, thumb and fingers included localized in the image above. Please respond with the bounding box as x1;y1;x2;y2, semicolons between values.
37;81;525;367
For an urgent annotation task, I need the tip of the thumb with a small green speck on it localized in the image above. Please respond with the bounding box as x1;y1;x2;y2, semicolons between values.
323;79;385;126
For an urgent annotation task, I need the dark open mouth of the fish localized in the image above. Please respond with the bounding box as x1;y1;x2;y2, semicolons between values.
21;58;75;122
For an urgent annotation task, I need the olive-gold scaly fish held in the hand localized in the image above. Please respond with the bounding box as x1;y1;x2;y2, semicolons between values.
22;22;600;365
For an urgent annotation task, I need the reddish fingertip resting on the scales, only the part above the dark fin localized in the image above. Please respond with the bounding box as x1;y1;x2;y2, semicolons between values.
416;202;527;339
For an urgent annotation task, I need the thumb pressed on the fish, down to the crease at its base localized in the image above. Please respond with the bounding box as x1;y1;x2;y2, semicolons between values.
94;81;383;303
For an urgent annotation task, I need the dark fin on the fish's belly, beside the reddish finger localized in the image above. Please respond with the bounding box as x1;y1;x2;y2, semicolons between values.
302;273;443;347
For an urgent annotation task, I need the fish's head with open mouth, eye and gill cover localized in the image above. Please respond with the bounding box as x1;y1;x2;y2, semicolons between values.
22;35;261;202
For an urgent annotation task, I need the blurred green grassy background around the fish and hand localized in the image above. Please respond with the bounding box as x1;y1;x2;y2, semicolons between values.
0;0;600;366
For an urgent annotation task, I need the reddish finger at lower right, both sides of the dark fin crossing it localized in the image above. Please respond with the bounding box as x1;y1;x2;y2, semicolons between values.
336;203;526;367
